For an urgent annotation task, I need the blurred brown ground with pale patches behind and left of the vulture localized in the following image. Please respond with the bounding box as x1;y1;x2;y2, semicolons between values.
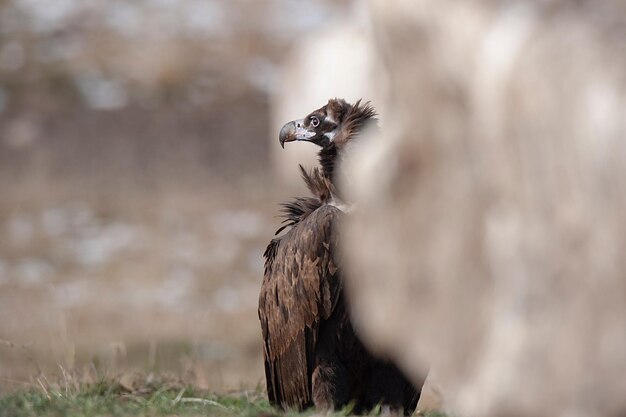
0;0;357;391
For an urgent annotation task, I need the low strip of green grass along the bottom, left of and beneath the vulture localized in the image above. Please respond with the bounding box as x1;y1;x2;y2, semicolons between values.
0;375;446;417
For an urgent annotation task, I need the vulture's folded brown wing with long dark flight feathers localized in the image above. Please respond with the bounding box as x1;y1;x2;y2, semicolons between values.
259;205;341;409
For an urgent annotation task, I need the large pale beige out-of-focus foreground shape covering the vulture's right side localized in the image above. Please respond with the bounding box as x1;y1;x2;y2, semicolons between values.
342;0;626;417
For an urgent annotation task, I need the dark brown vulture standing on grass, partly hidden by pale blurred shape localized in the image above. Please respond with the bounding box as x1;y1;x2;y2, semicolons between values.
258;98;421;415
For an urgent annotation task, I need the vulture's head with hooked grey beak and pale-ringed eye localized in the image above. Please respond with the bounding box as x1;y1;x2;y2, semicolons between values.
278;98;352;148
